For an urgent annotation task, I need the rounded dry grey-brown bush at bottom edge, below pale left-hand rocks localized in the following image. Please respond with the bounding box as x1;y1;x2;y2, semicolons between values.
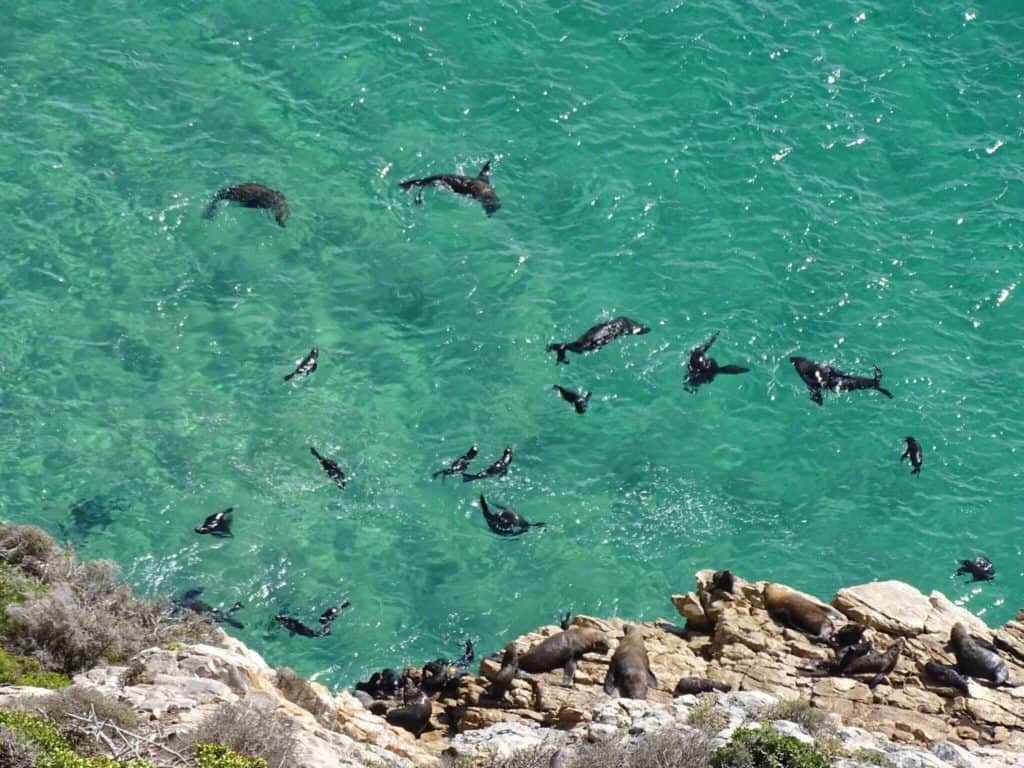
186;701;295;768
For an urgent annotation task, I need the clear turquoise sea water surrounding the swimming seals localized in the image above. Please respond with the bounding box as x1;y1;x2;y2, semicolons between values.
0;0;1024;685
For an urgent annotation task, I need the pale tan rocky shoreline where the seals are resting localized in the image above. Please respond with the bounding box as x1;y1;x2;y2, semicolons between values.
0;570;1024;768
